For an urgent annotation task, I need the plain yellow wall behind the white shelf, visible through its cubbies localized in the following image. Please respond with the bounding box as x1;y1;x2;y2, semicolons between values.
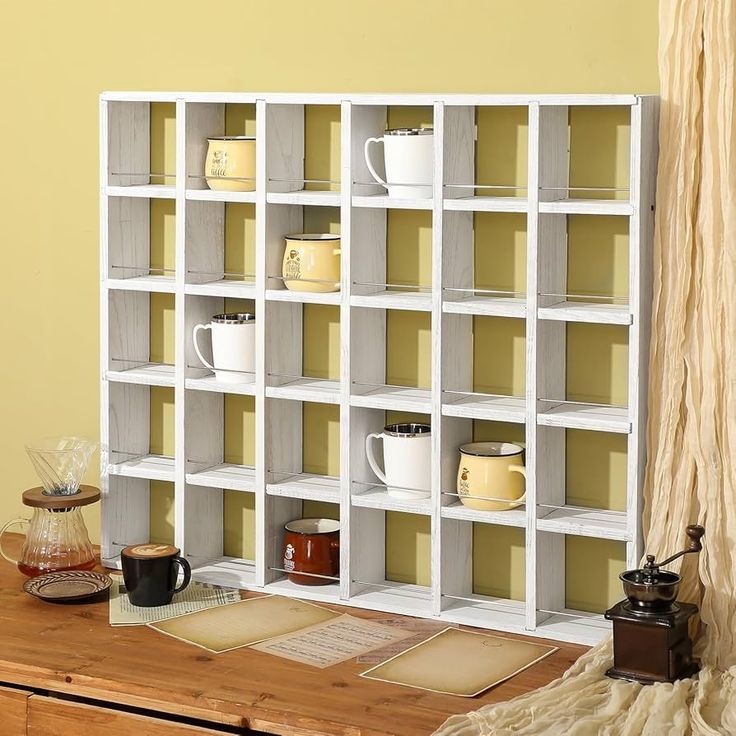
0;0;658;612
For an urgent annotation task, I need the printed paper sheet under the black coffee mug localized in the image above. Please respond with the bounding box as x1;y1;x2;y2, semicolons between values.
110;575;240;626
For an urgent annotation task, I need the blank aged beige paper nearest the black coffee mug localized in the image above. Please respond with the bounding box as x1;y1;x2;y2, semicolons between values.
149;595;340;654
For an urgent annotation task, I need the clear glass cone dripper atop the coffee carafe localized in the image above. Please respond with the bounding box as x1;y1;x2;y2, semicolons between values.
26;437;97;496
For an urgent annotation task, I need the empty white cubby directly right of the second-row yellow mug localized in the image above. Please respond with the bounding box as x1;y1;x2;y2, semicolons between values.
350;209;432;312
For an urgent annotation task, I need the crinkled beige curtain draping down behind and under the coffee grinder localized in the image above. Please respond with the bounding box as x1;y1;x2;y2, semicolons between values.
437;0;736;736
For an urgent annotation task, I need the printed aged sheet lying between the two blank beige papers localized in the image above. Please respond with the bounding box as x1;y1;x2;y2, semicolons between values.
251;614;413;668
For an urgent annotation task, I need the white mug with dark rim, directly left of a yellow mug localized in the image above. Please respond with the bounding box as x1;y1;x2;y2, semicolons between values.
365;423;432;499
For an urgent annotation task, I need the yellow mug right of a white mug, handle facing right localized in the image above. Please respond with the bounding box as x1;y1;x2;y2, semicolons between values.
457;442;526;511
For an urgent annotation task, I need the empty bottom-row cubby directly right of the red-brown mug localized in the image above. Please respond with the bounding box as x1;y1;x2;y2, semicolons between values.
350;508;432;617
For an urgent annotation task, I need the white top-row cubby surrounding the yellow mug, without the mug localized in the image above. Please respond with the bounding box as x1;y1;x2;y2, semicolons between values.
185;99;256;204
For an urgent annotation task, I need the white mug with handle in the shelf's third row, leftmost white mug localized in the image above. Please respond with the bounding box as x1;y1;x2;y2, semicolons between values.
192;312;256;383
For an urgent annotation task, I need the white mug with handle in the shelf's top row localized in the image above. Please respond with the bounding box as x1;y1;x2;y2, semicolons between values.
363;128;434;199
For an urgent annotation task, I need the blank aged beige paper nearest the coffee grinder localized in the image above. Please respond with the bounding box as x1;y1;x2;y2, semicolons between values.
361;628;557;698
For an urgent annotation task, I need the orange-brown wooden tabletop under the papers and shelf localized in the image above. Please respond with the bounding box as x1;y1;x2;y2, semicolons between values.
0;537;586;736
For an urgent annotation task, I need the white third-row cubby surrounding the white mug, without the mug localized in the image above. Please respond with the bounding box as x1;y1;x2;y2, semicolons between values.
184;295;256;396
